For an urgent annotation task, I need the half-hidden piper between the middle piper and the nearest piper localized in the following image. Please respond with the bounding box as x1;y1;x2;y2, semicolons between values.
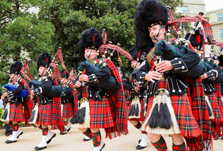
123;46;148;150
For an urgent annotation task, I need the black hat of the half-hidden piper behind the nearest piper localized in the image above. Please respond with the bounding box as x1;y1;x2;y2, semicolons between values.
129;46;146;62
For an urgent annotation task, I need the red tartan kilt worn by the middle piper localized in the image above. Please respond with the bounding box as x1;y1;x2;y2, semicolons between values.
89;97;114;128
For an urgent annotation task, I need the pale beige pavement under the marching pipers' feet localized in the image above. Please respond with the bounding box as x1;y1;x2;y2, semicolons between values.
0;123;223;151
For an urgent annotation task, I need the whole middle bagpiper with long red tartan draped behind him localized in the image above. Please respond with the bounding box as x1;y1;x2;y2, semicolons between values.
71;28;128;151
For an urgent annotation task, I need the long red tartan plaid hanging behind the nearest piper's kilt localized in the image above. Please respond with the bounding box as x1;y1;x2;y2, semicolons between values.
185;77;213;150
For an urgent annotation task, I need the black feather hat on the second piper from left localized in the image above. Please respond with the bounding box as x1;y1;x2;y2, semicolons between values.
37;52;52;69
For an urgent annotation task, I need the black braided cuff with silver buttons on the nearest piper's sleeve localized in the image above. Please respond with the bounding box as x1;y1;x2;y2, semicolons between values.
170;58;188;72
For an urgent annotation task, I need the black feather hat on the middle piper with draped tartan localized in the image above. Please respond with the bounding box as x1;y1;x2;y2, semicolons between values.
79;28;103;61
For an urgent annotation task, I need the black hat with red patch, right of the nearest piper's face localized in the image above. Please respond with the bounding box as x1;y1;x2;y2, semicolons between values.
185;29;204;50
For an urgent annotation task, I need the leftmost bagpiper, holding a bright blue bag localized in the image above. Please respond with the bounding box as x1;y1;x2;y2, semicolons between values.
1;61;30;144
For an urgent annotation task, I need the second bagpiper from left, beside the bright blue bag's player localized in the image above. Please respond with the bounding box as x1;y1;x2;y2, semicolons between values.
29;52;65;150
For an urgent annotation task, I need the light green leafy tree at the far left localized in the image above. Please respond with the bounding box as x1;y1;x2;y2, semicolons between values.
0;0;54;88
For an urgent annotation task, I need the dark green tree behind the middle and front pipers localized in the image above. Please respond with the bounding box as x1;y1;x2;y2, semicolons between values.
39;0;182;67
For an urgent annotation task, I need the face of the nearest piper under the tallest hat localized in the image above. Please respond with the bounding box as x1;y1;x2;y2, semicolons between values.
148;25;165;43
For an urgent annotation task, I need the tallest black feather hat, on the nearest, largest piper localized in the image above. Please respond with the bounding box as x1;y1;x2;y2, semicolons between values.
135;0;168;52
